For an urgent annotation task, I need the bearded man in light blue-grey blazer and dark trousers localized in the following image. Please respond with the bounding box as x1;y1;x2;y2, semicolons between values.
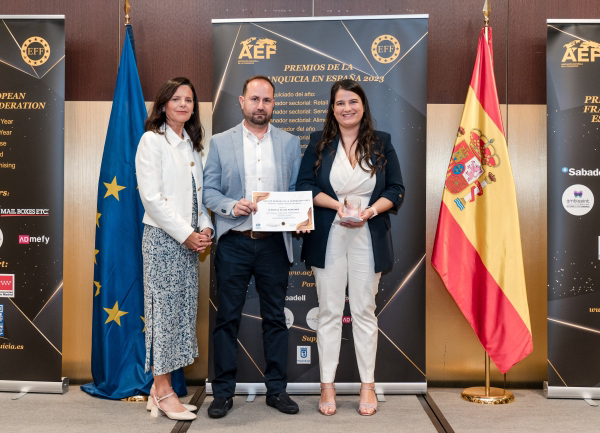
203;76;301;418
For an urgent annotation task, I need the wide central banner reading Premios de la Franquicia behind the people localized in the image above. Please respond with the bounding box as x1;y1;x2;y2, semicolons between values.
207;15;428;394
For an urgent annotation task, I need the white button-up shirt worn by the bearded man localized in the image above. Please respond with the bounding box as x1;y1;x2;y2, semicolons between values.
231;122;277;231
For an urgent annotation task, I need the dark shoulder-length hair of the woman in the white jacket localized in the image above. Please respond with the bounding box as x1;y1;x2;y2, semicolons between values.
146;77;204;152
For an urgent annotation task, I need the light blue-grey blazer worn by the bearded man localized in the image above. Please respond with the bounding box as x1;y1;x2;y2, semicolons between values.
202;123;302;263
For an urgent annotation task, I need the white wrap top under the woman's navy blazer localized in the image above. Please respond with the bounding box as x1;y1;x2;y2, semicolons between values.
329;140;376;224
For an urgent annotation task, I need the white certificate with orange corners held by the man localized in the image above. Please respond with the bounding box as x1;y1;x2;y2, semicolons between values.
252;191;314;232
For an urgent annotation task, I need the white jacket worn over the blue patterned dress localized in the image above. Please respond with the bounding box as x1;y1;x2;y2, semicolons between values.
135;124;214;244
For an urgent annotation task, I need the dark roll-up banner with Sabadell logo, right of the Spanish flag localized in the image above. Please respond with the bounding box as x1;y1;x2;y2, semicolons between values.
544;20;600;399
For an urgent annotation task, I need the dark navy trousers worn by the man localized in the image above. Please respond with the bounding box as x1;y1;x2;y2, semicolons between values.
212;233;290;397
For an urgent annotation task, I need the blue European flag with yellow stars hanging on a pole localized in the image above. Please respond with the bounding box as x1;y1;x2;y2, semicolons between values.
81;25;187;399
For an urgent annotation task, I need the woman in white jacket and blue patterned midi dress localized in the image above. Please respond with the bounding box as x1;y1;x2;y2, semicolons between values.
135;77;213;420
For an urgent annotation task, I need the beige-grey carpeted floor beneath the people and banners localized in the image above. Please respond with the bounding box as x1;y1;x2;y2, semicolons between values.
0;386;600;433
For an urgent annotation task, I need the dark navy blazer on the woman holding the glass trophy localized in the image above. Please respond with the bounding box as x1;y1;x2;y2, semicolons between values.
296;131;404;272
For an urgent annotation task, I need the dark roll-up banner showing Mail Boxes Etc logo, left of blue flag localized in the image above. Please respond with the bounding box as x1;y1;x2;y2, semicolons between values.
0;15;68;393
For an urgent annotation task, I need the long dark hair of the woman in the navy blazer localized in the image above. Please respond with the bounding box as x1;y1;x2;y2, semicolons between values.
314;80;387;176
